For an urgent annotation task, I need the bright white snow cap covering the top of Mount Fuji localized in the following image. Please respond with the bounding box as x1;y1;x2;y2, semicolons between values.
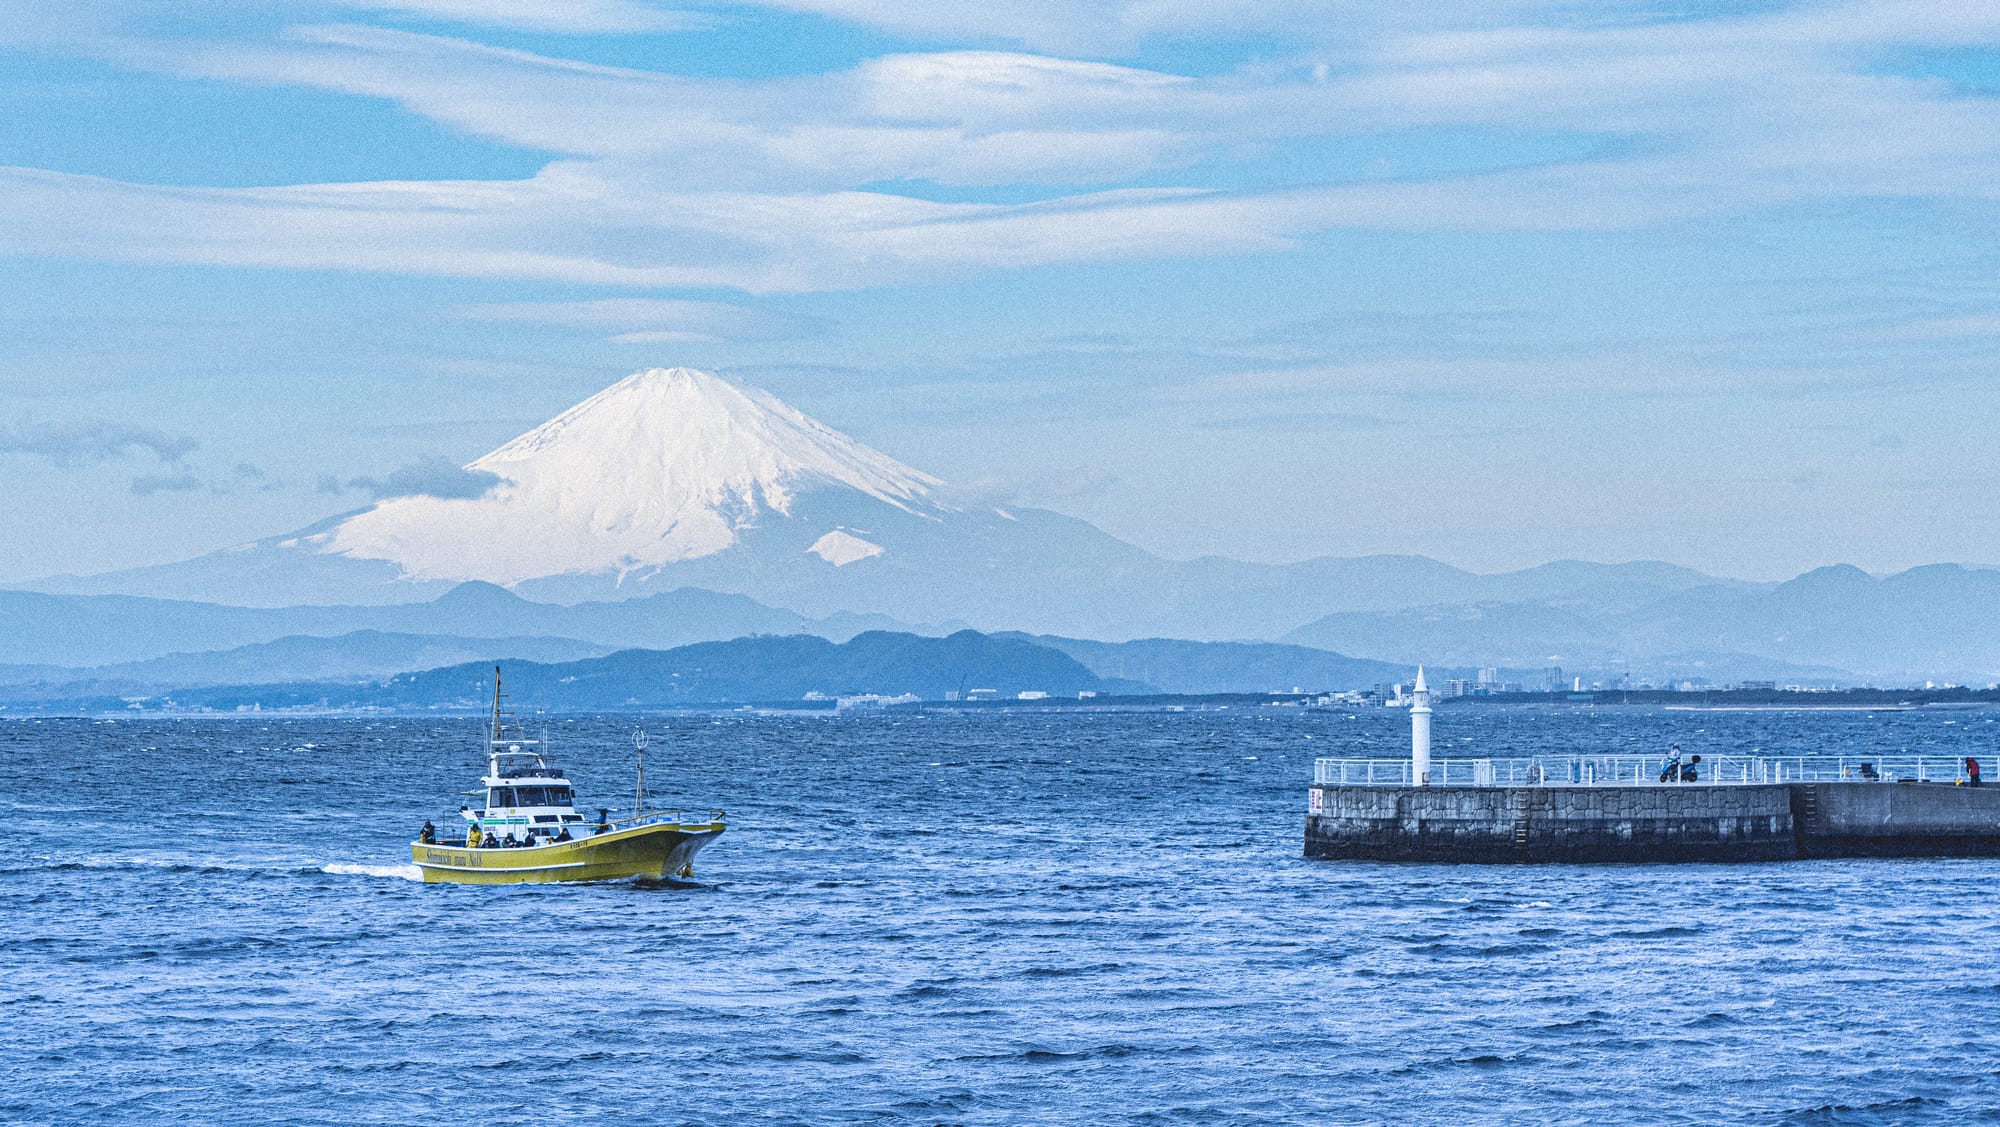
316;368;940;583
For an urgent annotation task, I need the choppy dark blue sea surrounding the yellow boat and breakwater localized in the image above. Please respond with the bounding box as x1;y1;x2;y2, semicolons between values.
11;707;2000;1125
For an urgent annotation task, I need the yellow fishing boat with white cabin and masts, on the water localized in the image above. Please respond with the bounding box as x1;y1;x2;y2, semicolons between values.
410;667;724;885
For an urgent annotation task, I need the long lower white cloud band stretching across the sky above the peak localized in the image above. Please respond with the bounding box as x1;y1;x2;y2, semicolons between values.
0;138;2000;292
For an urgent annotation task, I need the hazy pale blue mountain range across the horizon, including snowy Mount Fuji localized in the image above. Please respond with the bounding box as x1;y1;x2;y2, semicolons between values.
15;370;2000;689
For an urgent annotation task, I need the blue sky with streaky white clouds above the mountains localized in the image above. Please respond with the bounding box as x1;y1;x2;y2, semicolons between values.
0;0;2000;581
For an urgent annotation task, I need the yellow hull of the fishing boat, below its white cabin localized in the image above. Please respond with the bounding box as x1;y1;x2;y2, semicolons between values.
410;821;722;885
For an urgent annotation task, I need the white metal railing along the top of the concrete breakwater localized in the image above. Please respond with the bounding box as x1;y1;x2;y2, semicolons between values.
1312;753;1968;787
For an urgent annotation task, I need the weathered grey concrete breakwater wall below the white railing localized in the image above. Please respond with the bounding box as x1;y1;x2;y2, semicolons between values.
1306;781;2000;863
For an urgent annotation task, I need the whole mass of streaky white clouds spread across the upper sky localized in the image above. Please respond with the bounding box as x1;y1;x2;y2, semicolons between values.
11;0;2000;289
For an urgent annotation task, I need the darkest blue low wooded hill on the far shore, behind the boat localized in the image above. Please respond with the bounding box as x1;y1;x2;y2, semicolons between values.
0;629;1152;711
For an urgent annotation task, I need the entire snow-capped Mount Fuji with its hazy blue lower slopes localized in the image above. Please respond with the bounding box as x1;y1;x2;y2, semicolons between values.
34;368;1176;633
